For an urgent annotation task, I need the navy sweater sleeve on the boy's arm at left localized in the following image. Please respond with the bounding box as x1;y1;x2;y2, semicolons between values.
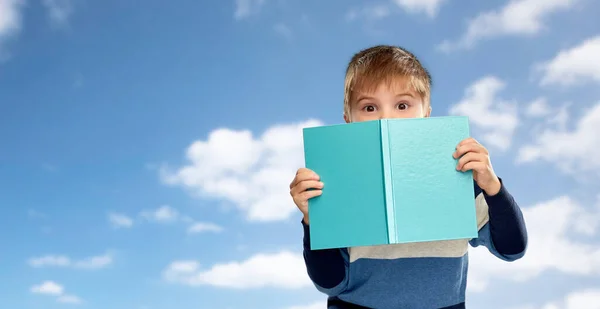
302;221;348;296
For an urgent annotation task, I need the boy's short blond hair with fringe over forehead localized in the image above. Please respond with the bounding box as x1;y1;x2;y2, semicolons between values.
344;45;431;116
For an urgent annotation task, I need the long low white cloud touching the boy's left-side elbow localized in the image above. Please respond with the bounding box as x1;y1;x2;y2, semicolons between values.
163;251;312;289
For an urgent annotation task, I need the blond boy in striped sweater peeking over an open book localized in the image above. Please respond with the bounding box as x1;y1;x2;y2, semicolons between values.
290;46;527;309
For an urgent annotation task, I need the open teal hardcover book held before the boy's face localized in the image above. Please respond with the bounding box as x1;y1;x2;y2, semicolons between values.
303;116;478;250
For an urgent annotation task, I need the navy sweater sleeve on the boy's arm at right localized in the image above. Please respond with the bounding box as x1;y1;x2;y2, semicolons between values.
470;180;527;261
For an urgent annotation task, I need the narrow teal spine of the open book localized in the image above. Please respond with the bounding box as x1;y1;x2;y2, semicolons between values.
379;119;397;244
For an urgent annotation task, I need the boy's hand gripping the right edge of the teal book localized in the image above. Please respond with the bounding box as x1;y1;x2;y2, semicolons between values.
453;137;502;195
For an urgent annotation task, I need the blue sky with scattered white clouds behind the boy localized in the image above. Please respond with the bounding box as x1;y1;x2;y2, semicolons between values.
0;0;600;309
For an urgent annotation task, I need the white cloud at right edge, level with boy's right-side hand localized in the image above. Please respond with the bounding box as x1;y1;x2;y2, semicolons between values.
517;102;600;177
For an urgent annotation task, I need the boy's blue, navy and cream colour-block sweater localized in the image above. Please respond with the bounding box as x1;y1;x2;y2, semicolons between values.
302;179;527;309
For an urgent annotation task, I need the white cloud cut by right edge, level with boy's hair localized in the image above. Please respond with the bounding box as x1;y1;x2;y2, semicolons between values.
536;36;600;86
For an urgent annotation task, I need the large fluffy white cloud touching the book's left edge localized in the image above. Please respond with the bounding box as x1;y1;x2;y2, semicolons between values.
161;120;321;221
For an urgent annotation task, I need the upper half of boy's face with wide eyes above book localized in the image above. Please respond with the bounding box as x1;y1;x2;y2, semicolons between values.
344;80;431;123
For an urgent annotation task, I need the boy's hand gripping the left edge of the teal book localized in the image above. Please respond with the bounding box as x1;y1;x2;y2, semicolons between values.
290;168;323;225
